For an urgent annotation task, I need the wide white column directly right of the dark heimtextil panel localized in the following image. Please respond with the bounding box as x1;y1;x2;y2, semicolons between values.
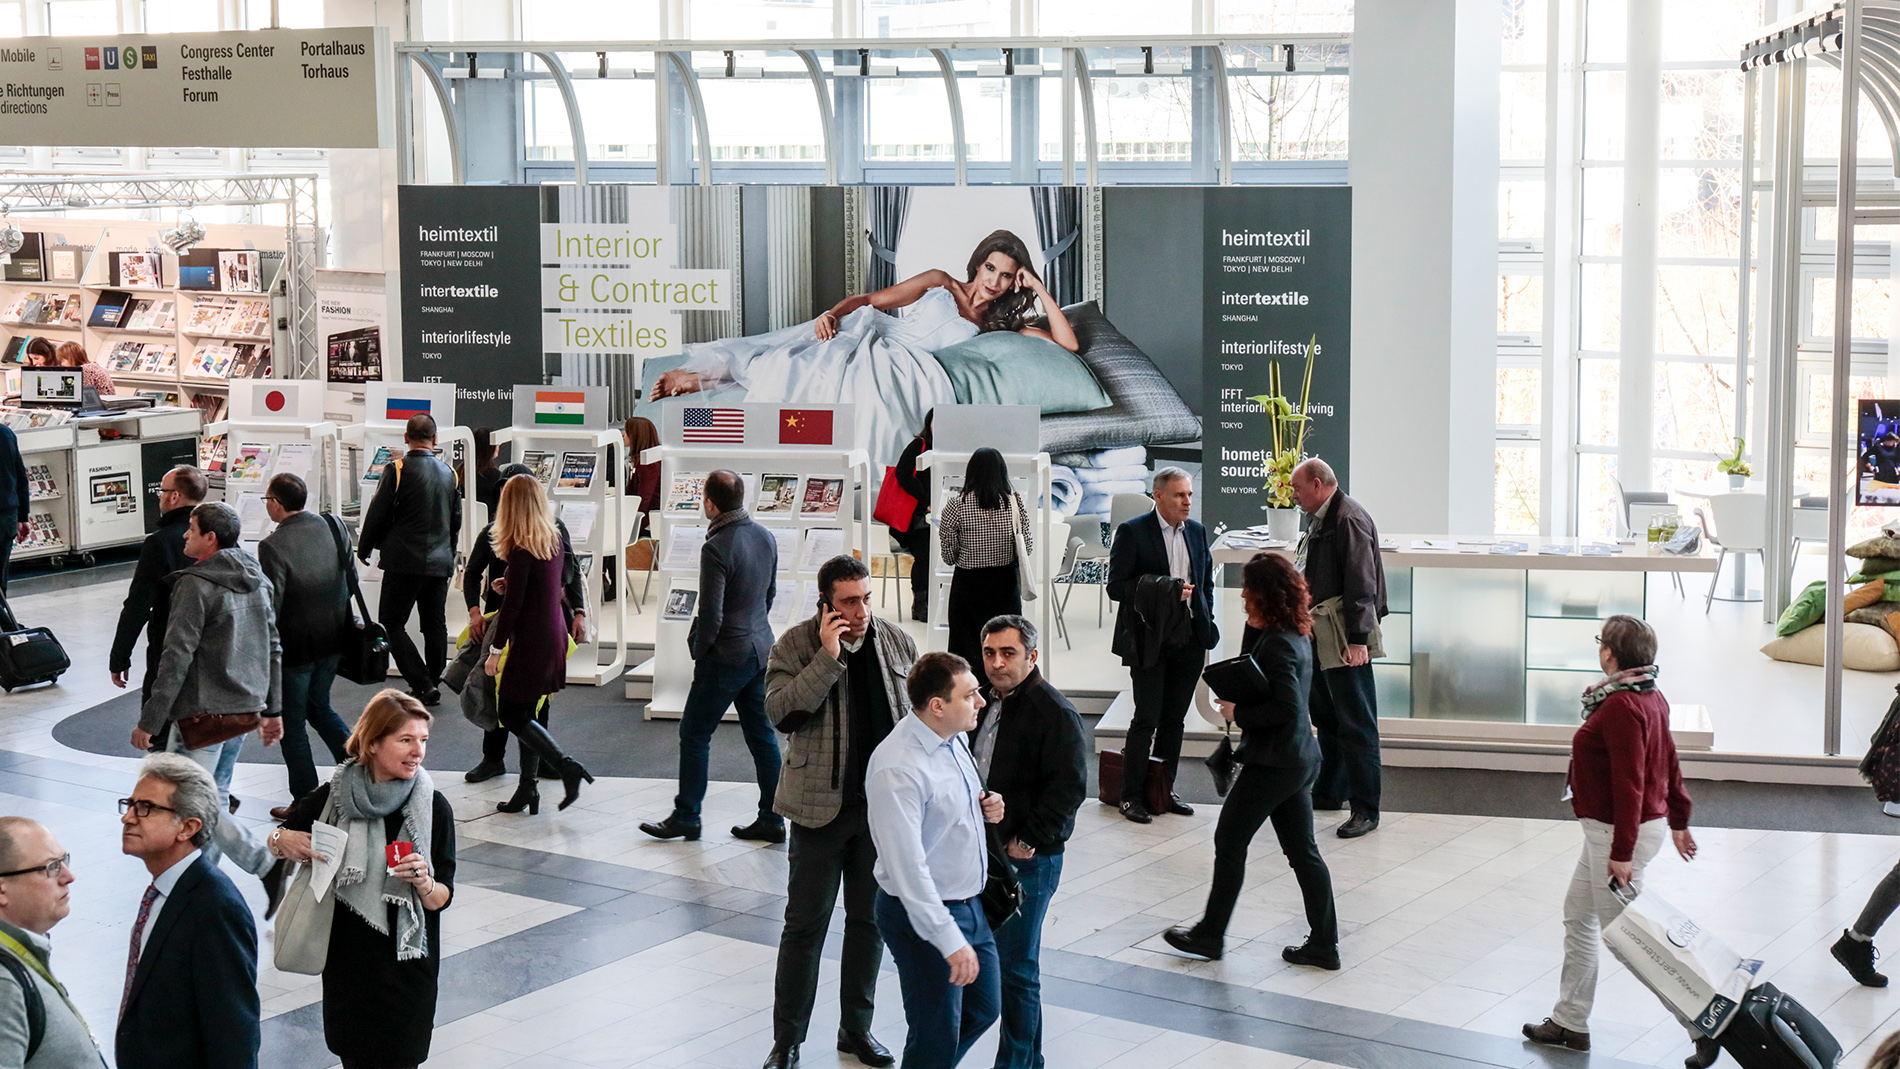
1349;0;1501;534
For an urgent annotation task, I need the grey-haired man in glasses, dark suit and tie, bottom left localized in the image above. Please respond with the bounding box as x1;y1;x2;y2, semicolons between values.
116;754;258;1069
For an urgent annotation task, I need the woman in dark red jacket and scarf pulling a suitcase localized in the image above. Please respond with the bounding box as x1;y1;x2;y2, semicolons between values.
1524;615;1721;1069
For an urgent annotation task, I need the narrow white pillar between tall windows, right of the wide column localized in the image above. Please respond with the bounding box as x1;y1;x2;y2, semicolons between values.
1617;0;1663;490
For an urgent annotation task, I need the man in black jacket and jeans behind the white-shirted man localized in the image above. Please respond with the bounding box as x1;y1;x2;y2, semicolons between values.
969;615;1089;1069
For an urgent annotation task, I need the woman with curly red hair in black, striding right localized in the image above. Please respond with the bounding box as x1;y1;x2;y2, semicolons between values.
1161;553;1340;968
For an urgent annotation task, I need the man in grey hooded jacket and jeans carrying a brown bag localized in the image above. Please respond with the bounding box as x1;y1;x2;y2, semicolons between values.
131;501;283;875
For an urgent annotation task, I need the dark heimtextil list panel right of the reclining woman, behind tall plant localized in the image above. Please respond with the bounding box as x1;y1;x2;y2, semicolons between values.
1201;186;1353;530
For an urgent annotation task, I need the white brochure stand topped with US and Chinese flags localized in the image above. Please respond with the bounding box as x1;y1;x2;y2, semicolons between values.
640;404;870;720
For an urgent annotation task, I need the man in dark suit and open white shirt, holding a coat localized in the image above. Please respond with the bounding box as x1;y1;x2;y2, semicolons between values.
1108;467;1220;824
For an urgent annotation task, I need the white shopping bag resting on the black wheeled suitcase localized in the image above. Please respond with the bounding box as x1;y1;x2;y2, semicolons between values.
1604;885;1761;1037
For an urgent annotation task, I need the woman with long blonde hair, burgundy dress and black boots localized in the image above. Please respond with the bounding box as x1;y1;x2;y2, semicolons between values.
483;475;593;815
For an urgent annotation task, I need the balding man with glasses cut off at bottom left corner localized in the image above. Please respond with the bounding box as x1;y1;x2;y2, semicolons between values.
0;816;106;1069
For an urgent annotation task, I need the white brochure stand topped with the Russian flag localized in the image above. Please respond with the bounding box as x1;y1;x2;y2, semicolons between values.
345;382;483;676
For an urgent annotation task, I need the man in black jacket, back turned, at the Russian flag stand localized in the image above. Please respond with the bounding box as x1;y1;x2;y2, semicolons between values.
357;412;462;704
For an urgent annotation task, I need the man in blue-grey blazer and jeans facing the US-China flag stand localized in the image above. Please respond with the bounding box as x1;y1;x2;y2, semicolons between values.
640;469;785;843
